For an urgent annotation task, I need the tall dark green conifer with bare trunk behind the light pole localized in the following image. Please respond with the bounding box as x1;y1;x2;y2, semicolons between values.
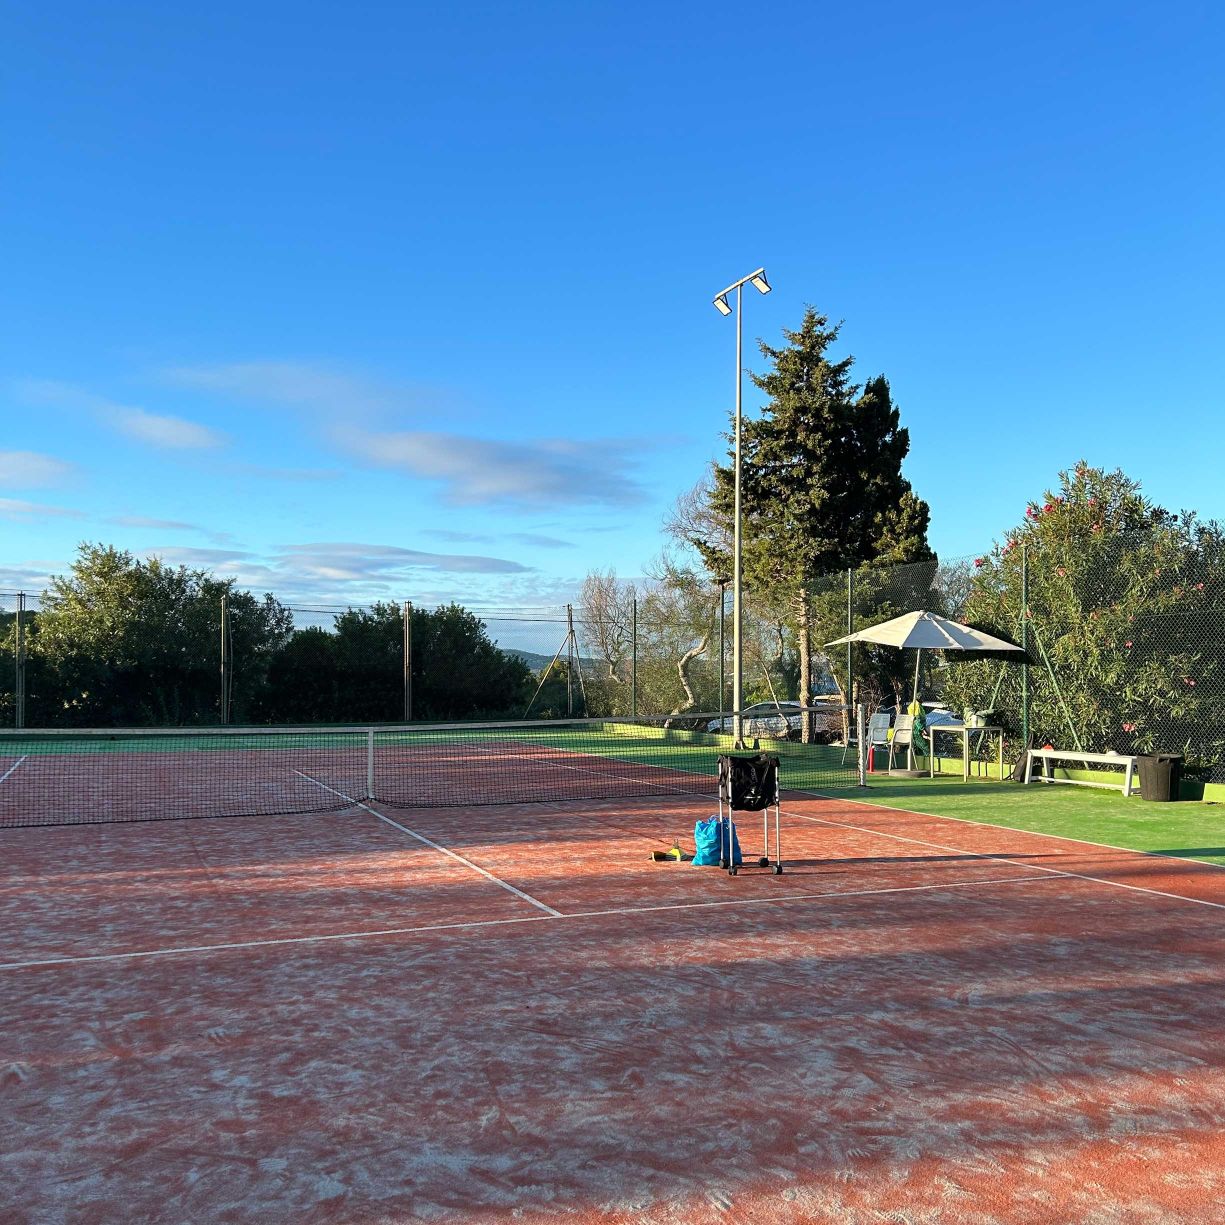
691;306;935;739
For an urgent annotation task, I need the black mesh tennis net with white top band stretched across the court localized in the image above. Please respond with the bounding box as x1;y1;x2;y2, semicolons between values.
0;709;858;828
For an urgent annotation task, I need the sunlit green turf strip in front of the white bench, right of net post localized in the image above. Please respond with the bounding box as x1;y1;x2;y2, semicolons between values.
853;774;1225;866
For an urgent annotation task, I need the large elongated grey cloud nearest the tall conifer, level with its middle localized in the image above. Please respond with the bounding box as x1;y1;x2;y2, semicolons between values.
336;426;642;507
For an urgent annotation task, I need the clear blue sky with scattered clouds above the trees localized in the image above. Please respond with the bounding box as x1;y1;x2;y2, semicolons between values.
0;0;1225;608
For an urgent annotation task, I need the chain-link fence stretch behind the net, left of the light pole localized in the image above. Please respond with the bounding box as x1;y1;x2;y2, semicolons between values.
0;589;735;728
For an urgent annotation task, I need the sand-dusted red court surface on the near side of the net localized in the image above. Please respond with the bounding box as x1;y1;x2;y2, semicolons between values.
0;797;1225;1225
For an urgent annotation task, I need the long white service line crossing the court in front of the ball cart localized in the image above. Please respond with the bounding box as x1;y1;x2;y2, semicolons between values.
0;877;1050;971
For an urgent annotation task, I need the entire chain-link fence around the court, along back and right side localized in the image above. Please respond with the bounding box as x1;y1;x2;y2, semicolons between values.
0;527;1225;782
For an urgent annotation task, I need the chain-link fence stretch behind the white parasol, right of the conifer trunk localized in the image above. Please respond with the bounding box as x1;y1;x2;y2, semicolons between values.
816;539;1225;782
